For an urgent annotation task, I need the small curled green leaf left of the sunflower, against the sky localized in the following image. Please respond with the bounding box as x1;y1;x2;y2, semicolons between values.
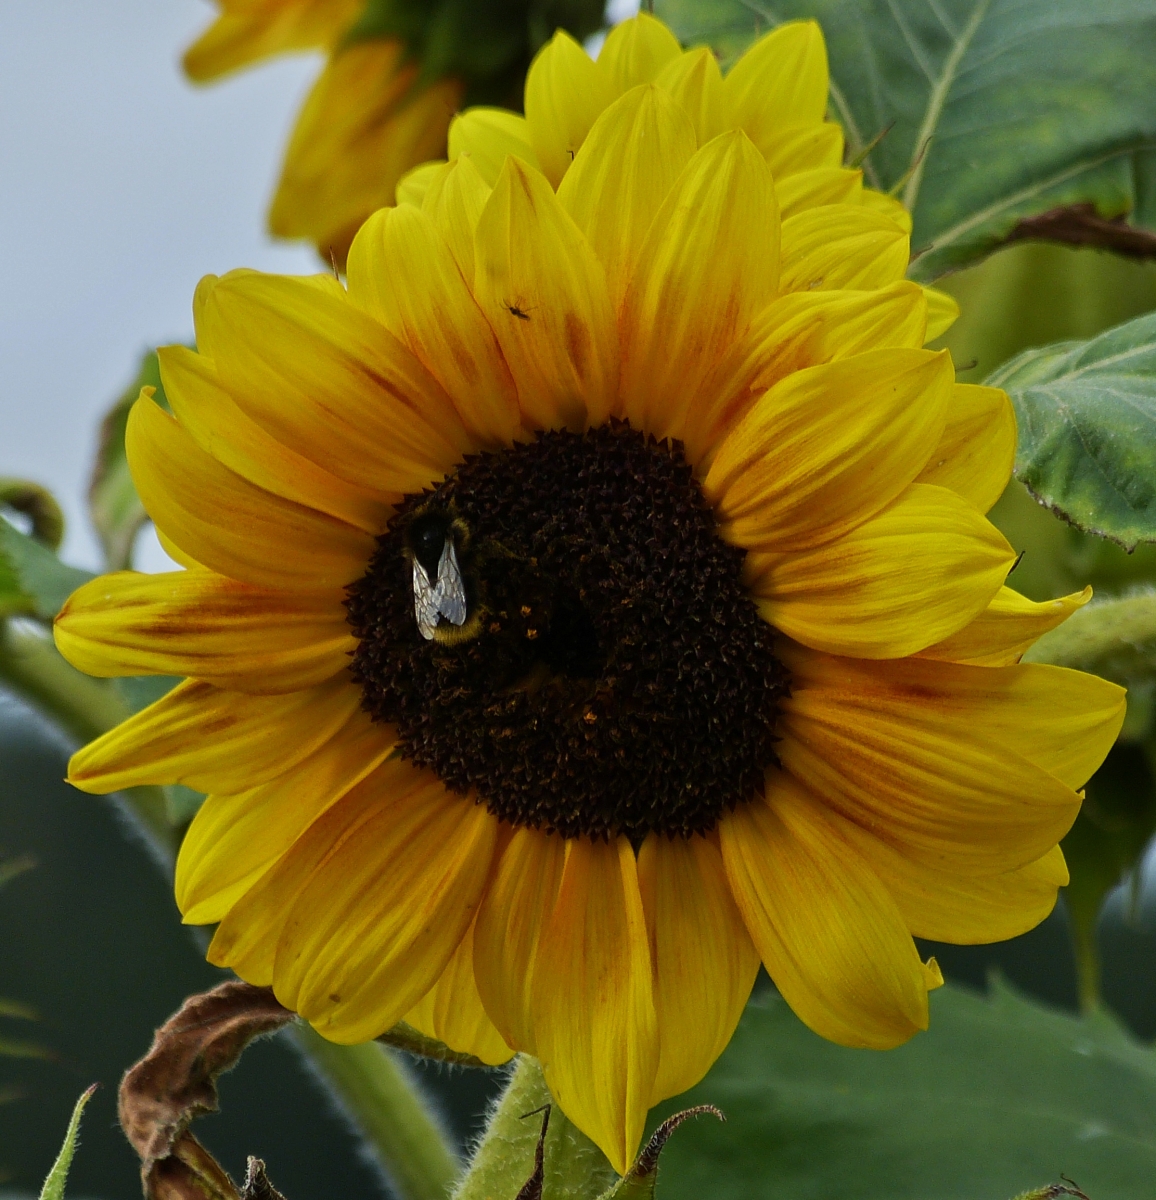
89;350;157;571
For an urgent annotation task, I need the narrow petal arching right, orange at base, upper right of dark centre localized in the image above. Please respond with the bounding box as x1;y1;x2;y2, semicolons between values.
679;280;927;474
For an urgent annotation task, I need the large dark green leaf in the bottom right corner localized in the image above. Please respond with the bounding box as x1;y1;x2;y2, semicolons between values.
652;984;1156;1200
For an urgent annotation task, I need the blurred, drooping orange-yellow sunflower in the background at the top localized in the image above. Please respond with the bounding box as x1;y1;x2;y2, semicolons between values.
184;0;603;268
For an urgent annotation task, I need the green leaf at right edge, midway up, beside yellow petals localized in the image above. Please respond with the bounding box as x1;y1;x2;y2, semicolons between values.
987;313;1156;550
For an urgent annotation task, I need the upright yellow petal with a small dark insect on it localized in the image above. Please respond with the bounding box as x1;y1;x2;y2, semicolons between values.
474;158;618;430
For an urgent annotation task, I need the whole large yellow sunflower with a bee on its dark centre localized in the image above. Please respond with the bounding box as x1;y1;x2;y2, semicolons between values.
56;17;1124;1171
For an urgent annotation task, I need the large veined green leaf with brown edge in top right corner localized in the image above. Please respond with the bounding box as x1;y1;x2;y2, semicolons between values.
655;0;1156;281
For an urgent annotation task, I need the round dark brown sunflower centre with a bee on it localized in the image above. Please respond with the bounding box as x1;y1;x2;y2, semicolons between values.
347;424;787;841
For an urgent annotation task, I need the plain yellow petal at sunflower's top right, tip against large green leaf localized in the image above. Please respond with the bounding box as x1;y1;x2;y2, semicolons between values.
723;20;827;154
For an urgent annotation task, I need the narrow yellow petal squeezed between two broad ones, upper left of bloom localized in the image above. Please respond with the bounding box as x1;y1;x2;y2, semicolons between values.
156;346;400;535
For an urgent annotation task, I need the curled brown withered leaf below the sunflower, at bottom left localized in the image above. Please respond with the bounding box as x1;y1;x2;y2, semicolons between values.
120;982;294;1200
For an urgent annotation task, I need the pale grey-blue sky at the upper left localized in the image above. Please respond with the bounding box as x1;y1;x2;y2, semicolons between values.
0;0;321;570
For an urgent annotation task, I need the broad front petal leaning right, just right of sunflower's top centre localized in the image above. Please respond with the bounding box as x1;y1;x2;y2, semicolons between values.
619;132;779;437
